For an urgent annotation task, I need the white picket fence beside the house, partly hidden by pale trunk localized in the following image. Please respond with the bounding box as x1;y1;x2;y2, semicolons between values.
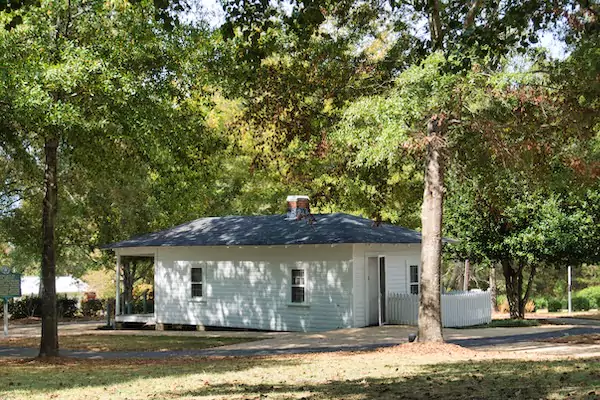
386;291;492;328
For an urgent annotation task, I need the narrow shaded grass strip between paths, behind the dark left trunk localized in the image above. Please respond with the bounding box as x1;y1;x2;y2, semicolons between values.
0;334;260;351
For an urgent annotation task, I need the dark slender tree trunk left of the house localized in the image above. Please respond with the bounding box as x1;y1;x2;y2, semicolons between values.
39;137;58;357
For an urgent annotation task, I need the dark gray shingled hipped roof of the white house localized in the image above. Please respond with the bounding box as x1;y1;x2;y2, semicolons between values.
104;213;421;249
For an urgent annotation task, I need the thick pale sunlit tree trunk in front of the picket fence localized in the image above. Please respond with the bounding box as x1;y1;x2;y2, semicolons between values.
419;115;445;342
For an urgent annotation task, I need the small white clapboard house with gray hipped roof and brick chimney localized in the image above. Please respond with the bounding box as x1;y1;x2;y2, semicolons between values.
106;197;428;332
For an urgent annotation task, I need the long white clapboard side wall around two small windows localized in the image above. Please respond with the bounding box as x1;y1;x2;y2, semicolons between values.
154;245;354;332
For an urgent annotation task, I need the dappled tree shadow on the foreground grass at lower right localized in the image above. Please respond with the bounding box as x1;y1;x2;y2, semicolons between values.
171;359;600;400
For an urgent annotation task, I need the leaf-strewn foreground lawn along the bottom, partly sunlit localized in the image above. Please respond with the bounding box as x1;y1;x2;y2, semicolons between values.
0;349;600;400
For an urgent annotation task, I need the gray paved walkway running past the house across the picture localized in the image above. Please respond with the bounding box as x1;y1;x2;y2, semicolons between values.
0;323;600;359
